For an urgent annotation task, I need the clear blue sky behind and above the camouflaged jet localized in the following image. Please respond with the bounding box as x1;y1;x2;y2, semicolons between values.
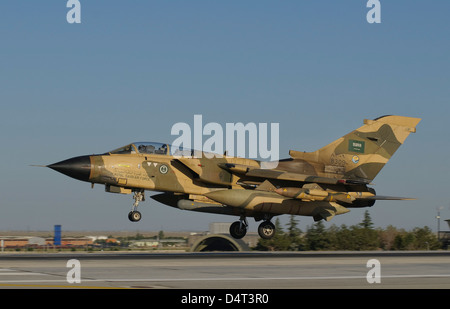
0;0;450;231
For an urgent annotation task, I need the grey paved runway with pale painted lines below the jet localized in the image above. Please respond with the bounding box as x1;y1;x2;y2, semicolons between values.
0;251;450;290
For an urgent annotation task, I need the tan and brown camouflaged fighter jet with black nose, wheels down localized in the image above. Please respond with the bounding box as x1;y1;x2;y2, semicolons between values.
44;116;421;239
